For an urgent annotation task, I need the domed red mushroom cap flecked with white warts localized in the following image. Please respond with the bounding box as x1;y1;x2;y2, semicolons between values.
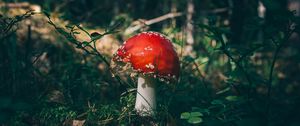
113;32;180;80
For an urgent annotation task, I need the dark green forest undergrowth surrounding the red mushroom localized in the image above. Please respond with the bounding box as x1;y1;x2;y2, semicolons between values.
0;0;300;126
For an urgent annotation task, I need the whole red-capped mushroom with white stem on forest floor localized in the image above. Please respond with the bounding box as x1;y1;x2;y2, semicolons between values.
112;32;179;116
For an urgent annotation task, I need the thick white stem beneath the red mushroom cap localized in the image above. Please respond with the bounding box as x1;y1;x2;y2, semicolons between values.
135;75;156;116
